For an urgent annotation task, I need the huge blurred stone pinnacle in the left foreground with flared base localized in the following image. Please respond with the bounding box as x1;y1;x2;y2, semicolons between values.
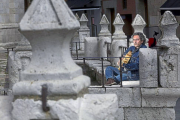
13;0;90;95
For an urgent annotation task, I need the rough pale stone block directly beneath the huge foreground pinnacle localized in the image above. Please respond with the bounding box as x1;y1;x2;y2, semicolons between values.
12;99;80;120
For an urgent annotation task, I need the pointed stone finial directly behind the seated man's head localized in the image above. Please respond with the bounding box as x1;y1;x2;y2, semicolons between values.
129;14;149;47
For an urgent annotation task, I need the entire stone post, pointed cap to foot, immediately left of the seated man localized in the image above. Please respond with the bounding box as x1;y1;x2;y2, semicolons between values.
111;13;127;66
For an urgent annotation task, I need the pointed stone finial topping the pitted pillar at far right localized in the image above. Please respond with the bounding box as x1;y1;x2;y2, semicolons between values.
158;11;179;47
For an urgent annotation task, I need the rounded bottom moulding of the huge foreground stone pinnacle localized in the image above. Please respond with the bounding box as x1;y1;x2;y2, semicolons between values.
12;75;90;95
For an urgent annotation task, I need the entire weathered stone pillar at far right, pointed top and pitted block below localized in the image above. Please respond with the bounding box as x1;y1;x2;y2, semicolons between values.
158;11;180;88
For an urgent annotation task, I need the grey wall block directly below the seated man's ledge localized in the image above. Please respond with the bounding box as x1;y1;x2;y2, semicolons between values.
106;88;141;107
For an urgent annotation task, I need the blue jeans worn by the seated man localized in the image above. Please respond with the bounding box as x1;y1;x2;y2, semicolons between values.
105;66;129;83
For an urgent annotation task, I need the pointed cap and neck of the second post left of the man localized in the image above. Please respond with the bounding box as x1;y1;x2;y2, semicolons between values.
99;14;111;37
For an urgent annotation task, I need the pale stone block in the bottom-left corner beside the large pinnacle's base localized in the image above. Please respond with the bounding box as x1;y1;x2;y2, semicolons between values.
0;96;13;120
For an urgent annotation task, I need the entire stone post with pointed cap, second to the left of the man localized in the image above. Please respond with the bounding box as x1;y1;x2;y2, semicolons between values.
98;14;111;57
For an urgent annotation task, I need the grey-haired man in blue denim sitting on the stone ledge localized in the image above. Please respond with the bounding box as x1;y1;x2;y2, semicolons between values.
105;32;147;85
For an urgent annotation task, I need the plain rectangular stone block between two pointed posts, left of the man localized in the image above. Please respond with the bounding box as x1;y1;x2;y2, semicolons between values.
84;37;99;57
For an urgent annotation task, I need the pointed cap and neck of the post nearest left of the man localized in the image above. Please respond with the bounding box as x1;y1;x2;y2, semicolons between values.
113;13;127;39
